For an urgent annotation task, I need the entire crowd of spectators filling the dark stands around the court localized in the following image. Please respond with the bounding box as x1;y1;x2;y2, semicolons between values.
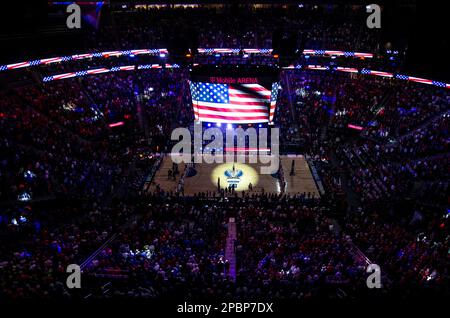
0;3;450;300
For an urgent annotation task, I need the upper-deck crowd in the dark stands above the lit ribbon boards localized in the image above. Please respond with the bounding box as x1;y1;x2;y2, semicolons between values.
91;6;379;52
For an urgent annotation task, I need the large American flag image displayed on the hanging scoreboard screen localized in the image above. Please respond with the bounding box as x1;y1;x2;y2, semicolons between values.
189;82;278;123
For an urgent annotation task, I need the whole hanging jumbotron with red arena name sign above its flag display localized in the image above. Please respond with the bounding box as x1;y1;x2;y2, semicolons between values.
189;65;280;124
